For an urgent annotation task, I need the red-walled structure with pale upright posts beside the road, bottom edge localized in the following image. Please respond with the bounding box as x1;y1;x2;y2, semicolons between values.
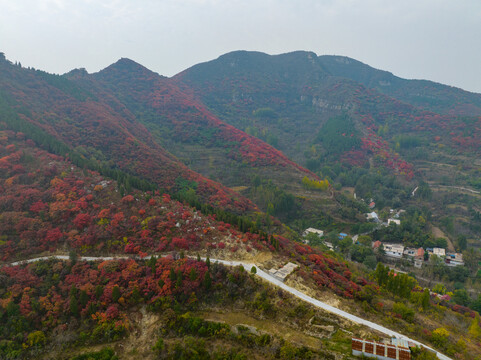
351;338;411;360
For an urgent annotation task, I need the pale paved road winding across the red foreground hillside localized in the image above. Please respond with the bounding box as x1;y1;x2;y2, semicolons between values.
9;255;451;360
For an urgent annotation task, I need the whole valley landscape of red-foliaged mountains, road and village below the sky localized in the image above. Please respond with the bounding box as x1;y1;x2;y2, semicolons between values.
0;51;481;360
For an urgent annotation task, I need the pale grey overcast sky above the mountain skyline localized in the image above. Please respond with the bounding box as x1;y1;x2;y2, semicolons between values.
0;0;481;92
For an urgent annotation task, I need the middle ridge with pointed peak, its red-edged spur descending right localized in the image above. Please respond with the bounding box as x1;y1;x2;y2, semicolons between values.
78;59;353;231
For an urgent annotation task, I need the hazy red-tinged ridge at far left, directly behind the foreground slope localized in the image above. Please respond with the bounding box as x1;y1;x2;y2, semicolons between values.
0;54;256;212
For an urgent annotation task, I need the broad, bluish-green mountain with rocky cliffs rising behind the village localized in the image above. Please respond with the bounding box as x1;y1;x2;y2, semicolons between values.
173;51;481;239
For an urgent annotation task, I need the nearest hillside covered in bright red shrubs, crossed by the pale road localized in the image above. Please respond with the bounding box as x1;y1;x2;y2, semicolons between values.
0;122;378;359
